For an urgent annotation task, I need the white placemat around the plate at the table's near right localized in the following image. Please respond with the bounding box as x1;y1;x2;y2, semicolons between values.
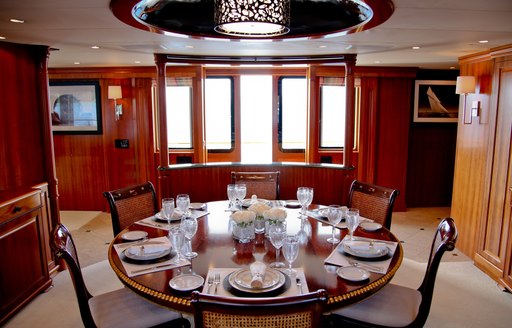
324;237;398;274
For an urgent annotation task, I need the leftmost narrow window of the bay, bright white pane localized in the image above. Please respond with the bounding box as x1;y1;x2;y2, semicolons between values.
165;78;192;149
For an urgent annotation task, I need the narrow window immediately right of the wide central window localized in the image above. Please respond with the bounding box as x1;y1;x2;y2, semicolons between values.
278;77;308;151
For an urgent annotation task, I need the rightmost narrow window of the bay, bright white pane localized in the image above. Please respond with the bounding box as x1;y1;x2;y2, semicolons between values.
320;78;346;148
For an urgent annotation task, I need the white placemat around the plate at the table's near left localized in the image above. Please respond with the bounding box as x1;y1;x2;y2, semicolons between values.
114;237;190;277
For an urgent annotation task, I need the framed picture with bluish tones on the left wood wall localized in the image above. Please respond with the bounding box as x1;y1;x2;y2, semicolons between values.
50;81;102;134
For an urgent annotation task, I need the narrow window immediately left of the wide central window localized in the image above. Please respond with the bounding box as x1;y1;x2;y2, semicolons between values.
205;76;235;152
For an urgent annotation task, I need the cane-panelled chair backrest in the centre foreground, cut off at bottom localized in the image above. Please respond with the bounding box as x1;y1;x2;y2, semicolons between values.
192;289;327;328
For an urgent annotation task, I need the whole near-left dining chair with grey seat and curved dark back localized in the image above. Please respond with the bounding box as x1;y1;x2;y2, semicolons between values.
50;224;190;328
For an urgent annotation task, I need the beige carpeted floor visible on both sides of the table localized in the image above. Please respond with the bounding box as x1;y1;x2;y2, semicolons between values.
5;208;512;328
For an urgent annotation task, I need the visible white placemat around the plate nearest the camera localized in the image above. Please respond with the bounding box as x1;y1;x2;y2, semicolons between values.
201;268;309;298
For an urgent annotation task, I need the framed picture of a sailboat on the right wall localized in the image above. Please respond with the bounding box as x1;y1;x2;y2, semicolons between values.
414;80;459;123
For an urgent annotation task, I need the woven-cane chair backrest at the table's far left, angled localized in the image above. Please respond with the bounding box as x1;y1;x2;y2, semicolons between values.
103;181;158;236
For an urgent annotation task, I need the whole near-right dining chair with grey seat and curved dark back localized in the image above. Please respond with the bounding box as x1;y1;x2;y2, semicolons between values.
330;218;458;328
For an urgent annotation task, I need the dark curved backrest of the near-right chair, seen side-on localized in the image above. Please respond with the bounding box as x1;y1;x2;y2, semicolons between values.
409;218;458;327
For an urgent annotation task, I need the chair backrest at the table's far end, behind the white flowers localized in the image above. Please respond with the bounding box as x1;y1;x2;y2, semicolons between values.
231;171;279;200
